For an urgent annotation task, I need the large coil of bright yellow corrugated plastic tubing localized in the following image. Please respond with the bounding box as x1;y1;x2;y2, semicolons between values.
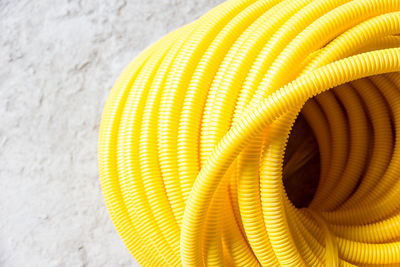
99;0;400;266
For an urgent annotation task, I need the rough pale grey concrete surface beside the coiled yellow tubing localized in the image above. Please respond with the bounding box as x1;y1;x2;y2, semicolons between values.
0;0;222;267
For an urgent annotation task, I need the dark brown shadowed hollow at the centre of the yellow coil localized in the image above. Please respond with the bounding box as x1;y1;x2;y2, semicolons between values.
283;114;320;208
